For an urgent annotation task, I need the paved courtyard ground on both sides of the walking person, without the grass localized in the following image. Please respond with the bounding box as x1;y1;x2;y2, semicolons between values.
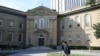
0;47;100;56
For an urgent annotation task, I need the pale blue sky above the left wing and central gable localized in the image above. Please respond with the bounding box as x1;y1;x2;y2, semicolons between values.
0;0;50;11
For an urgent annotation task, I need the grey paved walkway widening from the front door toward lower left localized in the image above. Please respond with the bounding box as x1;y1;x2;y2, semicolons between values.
9;47;51;56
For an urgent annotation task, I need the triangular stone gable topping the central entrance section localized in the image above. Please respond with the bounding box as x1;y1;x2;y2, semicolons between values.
26;6;58;16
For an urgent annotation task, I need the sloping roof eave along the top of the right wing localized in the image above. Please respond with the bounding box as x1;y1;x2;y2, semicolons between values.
59;4;100;16
